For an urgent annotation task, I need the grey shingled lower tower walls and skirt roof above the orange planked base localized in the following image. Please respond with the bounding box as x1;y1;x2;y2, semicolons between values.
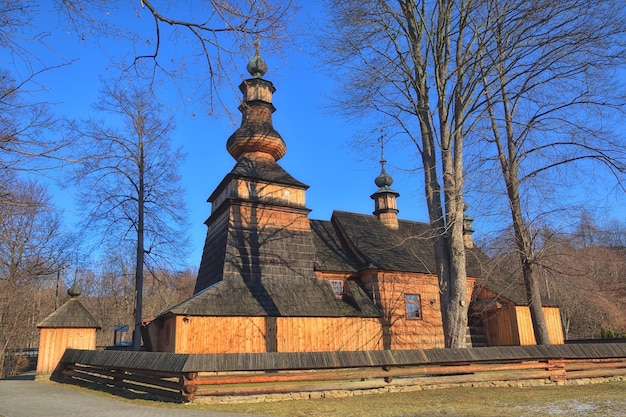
178;205;379;317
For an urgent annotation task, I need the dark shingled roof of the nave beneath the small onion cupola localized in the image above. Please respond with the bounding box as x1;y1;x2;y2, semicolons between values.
326;211;482;277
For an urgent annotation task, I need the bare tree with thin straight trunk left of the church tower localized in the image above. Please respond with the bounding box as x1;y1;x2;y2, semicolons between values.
73;79;188;350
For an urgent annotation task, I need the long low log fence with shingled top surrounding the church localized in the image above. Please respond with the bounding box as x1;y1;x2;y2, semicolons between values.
56;343;626;401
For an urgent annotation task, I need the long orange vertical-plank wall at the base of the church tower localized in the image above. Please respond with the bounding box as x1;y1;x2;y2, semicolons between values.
148;316;382;354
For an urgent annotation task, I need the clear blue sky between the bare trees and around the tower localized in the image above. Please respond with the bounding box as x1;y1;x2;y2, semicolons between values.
6;2;626;266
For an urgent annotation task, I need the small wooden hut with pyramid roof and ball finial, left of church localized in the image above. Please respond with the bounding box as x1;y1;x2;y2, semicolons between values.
37;283;100;379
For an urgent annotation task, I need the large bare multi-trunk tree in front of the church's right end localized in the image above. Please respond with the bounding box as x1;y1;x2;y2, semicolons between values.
323;0;494;347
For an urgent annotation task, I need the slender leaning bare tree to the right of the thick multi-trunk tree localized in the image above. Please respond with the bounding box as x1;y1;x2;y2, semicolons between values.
472;0;626;344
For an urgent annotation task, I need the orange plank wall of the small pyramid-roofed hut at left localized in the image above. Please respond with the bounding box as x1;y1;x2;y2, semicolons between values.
37;328;96;378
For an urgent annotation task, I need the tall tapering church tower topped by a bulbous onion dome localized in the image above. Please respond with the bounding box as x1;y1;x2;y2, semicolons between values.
195;43;338;316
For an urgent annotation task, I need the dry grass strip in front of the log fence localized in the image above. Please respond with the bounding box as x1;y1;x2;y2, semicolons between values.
53;381;626;417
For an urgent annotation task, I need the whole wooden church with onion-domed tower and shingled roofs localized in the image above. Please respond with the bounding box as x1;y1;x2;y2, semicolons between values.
142;52;560;353
